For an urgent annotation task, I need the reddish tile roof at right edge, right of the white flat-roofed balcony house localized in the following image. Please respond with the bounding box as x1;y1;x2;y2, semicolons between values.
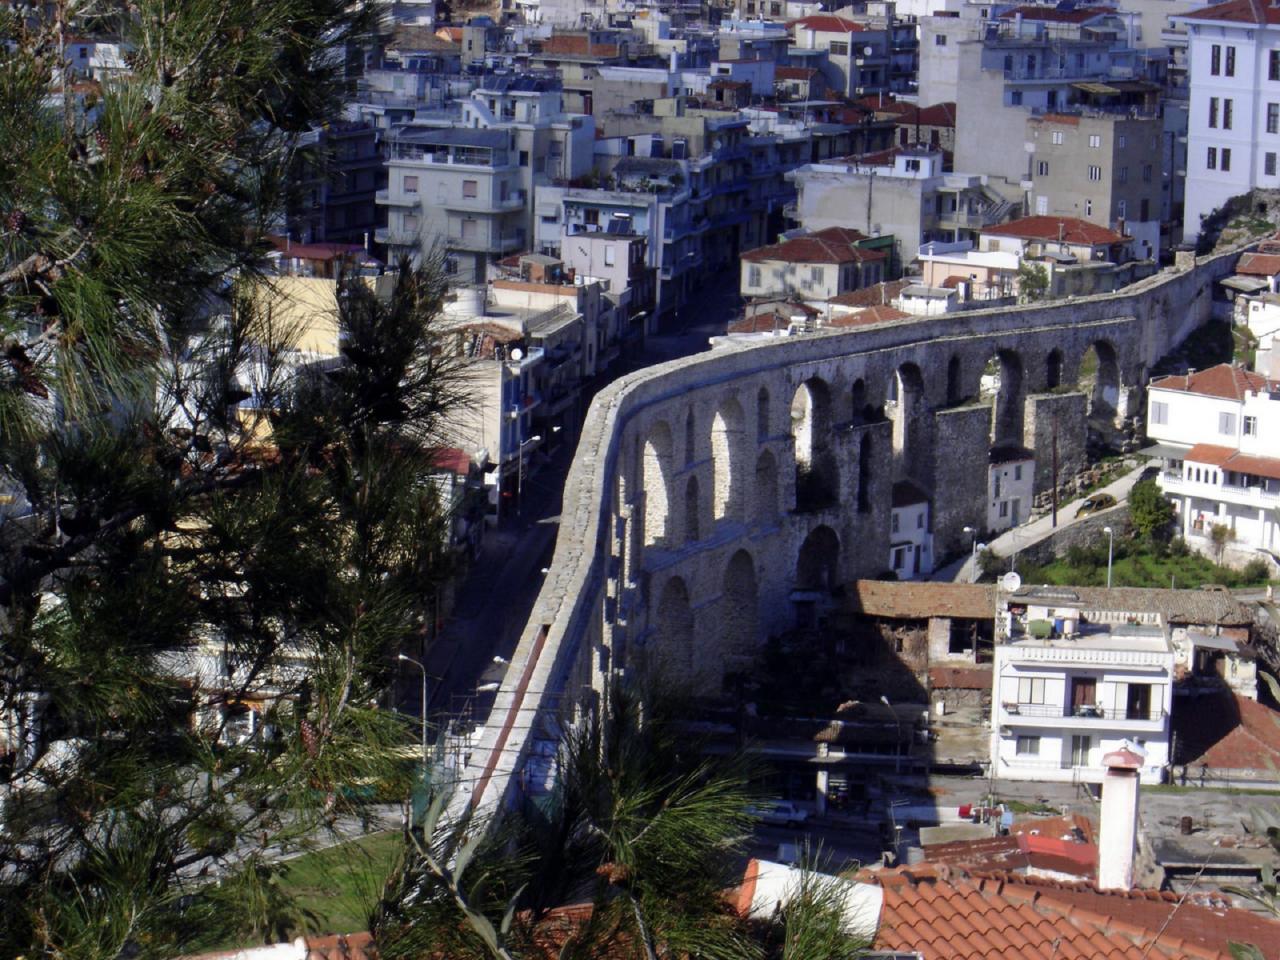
1174;690;1280;777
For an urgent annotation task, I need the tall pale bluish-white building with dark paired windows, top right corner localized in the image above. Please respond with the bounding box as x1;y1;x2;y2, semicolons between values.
1172;0;1280;243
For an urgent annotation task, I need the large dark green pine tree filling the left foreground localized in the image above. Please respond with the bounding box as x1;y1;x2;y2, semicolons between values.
0;0;473;960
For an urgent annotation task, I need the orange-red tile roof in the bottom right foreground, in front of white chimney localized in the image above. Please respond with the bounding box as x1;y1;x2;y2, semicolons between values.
858;864;1280;960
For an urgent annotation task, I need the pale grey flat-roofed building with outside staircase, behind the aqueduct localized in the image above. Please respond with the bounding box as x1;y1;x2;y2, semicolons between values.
790;147;1015;269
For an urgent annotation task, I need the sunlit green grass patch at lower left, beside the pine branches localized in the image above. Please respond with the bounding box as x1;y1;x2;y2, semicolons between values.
280;829;404;933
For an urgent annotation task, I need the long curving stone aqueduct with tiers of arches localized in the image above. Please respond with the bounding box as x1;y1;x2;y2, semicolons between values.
460;253;1235;804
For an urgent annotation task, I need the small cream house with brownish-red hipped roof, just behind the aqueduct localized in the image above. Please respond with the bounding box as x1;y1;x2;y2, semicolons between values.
739;227;888;300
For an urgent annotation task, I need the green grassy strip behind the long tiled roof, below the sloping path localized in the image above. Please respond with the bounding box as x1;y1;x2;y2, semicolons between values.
1018;538;1267;589
